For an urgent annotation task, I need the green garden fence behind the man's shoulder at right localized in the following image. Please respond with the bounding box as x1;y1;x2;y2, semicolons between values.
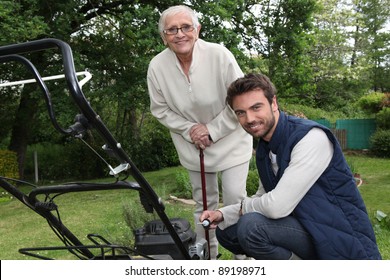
314;119;376;150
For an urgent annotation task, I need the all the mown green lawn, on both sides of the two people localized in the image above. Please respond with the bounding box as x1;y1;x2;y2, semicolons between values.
0;155;390;260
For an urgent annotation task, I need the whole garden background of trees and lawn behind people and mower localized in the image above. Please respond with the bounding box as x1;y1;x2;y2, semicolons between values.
0;0;390;260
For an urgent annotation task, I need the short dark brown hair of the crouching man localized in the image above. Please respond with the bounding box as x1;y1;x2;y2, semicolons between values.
226;73;276;107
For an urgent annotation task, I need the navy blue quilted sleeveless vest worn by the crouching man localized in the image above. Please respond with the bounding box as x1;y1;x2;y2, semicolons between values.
256;112;381;260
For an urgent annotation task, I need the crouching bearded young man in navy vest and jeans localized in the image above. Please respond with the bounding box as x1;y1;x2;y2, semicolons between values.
200;74;381;259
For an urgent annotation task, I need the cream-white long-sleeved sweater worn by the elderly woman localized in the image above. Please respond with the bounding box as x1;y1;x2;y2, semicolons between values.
147;39;252;172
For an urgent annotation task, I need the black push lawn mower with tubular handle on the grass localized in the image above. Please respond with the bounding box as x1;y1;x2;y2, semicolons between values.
0;38;209;260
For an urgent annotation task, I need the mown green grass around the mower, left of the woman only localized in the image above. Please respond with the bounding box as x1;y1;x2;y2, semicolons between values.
0;167;204;260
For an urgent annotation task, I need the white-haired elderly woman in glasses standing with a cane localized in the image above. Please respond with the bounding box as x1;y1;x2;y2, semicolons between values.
147;6;252;259
